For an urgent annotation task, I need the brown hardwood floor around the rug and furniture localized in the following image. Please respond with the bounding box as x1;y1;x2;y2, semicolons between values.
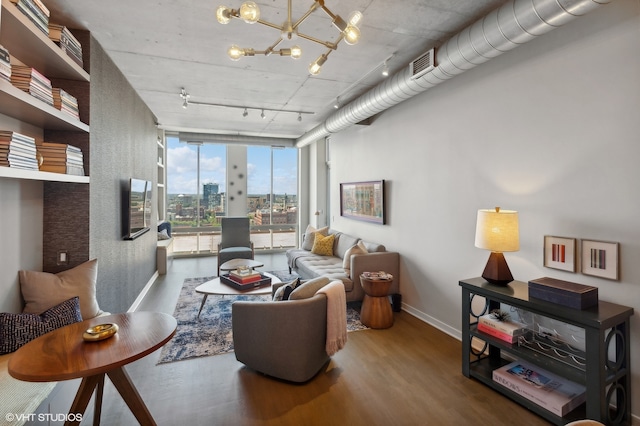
89;254;548;426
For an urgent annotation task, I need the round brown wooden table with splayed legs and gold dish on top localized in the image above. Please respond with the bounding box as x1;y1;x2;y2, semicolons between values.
8;312;177;425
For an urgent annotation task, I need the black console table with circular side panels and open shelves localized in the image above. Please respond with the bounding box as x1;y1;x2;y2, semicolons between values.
459;278;633;425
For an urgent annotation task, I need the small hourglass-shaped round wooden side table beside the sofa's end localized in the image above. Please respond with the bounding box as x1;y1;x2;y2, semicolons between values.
360;275;393;328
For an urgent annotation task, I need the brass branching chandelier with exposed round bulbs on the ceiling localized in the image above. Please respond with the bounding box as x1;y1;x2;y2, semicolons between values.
216;0;362;75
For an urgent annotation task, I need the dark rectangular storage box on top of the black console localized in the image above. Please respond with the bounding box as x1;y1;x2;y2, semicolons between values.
529;277;598;309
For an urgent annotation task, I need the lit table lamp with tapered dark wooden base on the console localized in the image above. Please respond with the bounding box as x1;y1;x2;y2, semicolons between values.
475;207;520;286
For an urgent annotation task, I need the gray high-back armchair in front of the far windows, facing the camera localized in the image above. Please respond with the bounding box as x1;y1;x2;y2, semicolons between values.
218;217;254;276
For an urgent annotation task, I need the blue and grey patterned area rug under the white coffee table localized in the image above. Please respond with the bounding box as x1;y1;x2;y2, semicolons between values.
158;271;368;364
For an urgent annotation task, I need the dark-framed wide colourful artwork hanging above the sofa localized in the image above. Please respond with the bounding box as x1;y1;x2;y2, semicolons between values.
340;180;385;225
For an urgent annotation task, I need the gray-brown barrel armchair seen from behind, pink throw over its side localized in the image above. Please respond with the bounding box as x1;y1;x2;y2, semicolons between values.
231;293;329;383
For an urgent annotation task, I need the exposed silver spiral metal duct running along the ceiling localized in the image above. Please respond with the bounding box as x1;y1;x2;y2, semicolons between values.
296;0;611;147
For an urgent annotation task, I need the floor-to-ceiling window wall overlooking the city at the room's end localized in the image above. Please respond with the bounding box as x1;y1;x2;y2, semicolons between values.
165;135;298;255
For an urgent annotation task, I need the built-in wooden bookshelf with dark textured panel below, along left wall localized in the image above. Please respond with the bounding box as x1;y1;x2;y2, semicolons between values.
0;0;91;272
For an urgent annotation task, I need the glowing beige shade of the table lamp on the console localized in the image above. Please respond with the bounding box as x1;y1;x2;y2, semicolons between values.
475;207;520;253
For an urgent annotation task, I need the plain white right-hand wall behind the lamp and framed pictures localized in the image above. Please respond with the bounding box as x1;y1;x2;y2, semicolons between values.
324;0;640;415
